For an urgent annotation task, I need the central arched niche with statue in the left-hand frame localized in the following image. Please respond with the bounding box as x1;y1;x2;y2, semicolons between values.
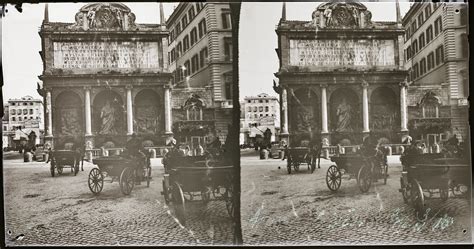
92;90;126;135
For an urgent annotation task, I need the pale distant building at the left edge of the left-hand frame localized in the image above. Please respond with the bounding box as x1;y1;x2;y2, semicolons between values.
2;96;44;148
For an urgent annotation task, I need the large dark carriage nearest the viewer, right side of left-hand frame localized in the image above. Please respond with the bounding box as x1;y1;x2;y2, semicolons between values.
162;153;234;225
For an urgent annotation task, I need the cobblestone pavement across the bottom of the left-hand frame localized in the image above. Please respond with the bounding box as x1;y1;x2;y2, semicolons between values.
3;154;233;246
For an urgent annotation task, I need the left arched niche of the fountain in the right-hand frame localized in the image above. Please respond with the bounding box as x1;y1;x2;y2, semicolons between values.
288;87;321;146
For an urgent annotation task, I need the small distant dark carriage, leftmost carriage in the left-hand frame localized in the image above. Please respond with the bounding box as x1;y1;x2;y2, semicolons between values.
49;150;84;177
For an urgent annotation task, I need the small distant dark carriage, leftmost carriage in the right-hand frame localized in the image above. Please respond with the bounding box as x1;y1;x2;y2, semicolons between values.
285;147;321;174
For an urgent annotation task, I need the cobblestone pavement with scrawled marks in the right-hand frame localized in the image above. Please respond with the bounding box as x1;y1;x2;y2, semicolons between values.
241;150;471;245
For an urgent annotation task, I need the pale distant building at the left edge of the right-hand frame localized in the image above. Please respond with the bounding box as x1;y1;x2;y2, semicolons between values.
240;93;280;144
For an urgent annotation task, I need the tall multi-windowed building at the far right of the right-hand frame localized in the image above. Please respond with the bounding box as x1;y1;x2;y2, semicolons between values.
403;3;469;146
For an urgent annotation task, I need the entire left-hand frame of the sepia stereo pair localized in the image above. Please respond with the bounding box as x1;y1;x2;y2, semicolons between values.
1;2;240;246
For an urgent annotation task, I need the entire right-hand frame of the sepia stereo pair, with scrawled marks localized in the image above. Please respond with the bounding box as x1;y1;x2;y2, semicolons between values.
239;1;472;245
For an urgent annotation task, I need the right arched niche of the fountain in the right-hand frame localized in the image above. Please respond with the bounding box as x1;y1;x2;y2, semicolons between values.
369;87;400;131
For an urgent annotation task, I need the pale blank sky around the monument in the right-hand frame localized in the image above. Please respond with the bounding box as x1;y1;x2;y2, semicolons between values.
239;0;410;100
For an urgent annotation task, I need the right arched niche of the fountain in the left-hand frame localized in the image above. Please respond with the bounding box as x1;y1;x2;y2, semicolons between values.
133;89;163;134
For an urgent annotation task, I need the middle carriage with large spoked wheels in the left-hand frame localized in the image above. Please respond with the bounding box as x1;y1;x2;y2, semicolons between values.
88;155;151;195
